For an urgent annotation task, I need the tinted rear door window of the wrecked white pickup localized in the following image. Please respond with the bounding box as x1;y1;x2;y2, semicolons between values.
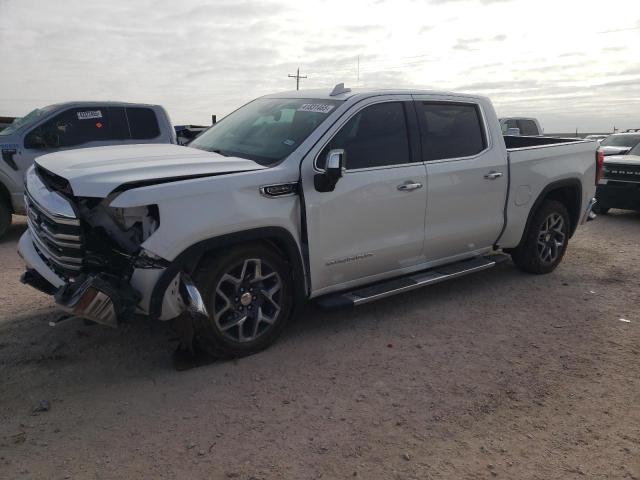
418;102;487;161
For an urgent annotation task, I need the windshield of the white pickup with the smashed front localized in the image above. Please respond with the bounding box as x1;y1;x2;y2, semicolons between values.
189;98;342;165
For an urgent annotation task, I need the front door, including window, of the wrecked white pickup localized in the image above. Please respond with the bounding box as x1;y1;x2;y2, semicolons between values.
303;96;426;295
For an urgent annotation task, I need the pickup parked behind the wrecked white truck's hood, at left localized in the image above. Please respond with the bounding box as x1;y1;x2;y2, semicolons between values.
0;102;176;238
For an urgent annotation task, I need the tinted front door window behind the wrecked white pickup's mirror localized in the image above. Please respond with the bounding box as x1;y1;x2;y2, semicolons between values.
317;102;411;170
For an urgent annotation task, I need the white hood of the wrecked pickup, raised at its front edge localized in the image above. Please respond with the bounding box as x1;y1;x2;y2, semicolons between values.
36;144;266;198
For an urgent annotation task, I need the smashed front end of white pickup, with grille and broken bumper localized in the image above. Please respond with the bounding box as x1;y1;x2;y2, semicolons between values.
18;168;206;327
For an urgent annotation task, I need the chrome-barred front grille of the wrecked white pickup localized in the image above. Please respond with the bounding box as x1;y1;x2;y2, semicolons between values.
25;170;84;277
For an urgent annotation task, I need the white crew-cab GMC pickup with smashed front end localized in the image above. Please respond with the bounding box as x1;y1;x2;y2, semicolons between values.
19;84;602;357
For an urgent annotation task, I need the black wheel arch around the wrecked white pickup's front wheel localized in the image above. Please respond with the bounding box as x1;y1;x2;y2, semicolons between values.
149;227;309;318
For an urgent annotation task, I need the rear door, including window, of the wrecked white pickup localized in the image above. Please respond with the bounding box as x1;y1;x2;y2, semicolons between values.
416;97;508;261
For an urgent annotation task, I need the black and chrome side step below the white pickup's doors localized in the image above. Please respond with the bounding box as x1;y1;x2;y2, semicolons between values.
316;253;509;308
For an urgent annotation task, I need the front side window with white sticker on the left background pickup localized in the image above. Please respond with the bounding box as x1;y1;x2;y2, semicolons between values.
25;107;111;149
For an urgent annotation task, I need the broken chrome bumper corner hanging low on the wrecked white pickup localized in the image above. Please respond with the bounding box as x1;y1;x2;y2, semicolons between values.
54;274;140;327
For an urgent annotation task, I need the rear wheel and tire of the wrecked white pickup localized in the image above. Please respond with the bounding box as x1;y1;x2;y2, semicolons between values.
511;200;569;274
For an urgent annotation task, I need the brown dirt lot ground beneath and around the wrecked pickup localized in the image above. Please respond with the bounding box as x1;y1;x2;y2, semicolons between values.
0;215;640;480
